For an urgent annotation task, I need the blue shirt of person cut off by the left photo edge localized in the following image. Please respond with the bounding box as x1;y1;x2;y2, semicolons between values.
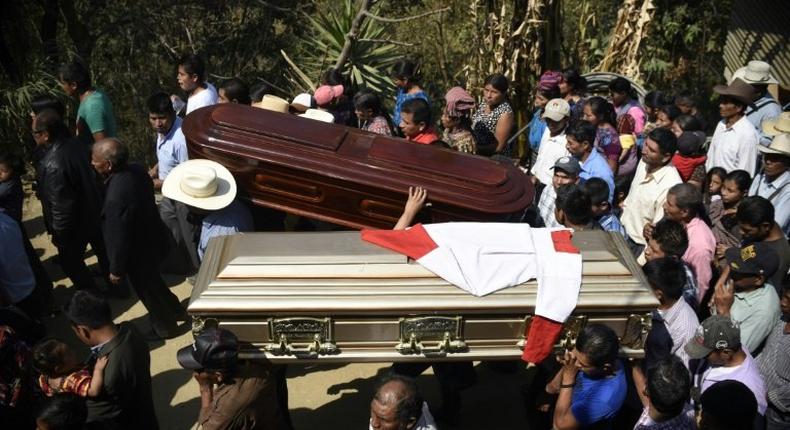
0;211;36;303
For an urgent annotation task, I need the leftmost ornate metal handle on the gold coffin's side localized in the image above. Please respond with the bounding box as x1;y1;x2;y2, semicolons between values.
263;317;340;359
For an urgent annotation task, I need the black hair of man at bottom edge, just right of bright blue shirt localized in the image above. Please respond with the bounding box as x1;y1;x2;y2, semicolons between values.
647;355;691;418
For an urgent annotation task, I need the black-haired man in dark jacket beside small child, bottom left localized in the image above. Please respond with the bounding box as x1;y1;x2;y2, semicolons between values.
64;291;159;430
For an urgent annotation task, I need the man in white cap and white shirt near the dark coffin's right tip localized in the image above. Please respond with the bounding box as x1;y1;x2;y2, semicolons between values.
532;99;571;186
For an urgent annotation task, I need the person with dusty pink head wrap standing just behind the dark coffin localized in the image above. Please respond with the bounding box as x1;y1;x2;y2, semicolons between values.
442;87;477;154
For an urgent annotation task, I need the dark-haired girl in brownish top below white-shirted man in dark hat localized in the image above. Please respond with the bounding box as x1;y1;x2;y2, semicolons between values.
708;170;752;263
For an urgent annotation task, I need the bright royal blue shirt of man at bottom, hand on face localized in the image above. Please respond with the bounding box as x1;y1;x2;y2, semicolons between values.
571;363;626;428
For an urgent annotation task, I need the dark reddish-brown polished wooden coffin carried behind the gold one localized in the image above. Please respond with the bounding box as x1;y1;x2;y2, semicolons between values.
183;104;534;228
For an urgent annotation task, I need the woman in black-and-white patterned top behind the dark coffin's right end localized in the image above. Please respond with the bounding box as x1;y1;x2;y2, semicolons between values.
472;73;514;157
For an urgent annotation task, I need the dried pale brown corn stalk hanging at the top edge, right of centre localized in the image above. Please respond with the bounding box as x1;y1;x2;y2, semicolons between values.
595;0;656;81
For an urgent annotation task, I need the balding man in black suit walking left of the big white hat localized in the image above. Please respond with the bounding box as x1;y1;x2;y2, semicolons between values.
91;138;186;339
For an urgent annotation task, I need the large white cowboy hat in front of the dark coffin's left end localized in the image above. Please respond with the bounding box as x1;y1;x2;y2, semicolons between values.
162;160;236;211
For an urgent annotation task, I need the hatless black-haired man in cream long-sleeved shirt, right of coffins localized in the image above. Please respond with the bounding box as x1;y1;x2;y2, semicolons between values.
620;128;683;256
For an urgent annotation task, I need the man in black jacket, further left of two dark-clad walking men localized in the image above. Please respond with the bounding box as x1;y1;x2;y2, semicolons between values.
33;109;107;290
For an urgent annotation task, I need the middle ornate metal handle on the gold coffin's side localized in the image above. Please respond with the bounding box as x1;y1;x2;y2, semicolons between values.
395;316;469;357
